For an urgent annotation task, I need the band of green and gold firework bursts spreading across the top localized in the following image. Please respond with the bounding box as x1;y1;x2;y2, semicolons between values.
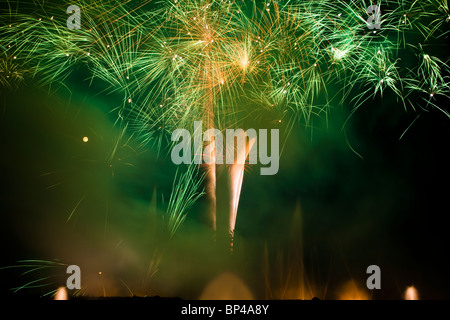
2;0;448;115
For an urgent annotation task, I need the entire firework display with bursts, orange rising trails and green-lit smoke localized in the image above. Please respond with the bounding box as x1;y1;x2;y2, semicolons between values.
0;0;450;300
